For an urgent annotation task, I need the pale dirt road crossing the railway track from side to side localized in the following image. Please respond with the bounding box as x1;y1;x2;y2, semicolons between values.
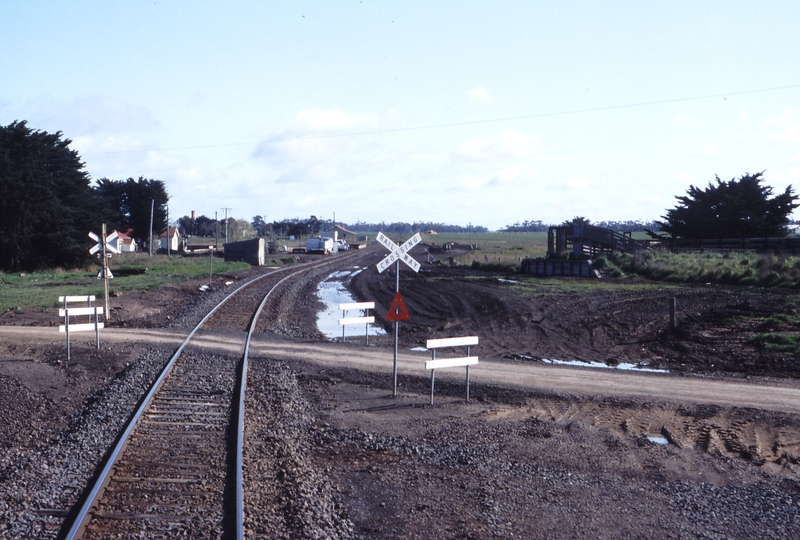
0;326;800;414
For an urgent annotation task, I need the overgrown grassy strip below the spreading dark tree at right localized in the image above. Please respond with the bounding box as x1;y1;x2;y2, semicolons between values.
594;251;800;288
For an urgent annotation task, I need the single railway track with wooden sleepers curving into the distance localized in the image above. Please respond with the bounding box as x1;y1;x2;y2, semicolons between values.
60;251;364;539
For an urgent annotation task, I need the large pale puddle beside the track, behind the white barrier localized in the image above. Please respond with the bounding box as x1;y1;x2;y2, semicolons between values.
317;266;386;339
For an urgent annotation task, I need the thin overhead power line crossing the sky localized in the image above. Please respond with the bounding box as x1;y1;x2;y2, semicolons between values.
83;84;800;156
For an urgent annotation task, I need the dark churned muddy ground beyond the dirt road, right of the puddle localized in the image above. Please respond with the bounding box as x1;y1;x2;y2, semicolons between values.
352;246;800;378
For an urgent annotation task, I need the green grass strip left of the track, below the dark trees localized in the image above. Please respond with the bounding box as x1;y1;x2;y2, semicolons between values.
0;253;255;313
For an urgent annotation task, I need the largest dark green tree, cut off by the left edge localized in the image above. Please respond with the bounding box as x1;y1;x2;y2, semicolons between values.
0;120;99;271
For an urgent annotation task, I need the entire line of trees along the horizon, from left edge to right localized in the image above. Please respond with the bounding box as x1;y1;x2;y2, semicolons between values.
0;121;800;272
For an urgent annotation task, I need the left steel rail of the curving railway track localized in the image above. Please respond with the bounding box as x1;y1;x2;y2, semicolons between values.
59;261;328;540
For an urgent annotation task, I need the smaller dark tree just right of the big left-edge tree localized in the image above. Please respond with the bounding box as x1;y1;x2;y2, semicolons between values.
95;176;169;245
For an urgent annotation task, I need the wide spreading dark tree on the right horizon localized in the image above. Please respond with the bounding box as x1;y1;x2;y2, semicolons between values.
656;171;798;239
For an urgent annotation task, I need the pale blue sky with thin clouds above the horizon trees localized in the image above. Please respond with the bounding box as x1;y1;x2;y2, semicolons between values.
0;0;800;229
